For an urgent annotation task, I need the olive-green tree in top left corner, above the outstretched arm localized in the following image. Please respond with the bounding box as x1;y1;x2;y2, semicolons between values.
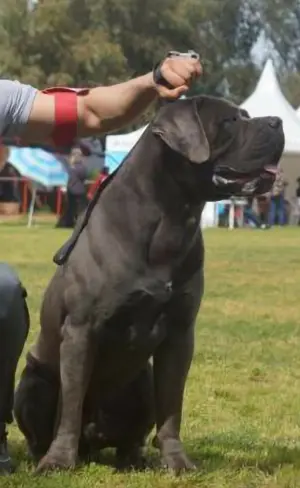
0;0;127;87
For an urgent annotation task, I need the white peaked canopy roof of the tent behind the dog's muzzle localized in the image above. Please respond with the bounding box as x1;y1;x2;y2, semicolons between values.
241;59;300;153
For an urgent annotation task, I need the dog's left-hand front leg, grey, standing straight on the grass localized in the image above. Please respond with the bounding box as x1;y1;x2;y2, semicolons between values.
37;318;94;472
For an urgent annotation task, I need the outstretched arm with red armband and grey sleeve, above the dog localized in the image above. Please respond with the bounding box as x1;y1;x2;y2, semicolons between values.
8;58;201;148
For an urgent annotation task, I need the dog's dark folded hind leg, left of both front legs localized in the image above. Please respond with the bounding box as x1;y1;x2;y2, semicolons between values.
14;353;59;461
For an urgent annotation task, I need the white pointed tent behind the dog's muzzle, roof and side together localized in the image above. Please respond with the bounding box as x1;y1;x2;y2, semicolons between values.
241;59;300;198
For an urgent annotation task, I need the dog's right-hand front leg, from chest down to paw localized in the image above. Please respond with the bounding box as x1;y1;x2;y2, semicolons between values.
153;269;204;474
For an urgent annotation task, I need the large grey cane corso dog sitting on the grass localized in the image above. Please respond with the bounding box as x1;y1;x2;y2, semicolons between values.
16;96;284;473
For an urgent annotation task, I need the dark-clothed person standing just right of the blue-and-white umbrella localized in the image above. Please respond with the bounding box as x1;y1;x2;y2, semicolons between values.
66;147;88;228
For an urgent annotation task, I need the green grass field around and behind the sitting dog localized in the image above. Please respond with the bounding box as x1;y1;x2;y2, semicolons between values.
0;224;300;488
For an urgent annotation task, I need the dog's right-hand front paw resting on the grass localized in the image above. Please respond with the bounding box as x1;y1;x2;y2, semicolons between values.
161;439;196;476
